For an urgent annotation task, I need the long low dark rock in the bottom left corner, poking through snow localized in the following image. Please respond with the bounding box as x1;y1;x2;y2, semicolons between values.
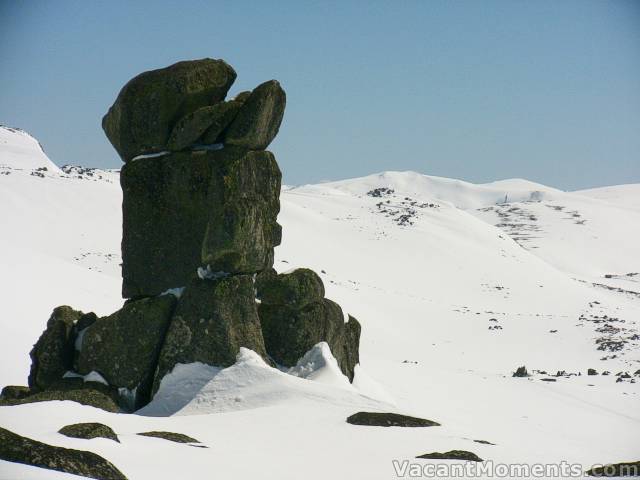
0;428;127;480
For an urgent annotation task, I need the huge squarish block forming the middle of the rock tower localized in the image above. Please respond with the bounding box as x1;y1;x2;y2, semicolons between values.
120;147;281;298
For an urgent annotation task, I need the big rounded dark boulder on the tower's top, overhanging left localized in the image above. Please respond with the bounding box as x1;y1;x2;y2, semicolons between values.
102;58;236;162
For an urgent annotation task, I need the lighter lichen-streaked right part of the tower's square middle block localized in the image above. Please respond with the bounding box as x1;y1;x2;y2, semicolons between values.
202;152;282;274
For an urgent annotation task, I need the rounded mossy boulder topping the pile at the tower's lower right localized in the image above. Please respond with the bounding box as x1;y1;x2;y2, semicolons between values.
258;268;324;308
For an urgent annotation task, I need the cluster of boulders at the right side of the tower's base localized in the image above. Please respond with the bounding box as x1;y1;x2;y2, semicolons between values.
257;269;360;381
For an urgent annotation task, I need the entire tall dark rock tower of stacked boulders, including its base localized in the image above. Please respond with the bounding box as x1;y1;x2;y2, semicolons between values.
0;59;360;410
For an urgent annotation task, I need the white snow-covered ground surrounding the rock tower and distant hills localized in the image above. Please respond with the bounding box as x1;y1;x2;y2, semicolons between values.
0;128;640;480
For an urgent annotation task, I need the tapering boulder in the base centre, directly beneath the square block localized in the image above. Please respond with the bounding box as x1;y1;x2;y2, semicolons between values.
153;275;266;392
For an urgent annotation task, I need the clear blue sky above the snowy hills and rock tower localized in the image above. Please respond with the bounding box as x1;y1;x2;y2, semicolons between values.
0;0;640;189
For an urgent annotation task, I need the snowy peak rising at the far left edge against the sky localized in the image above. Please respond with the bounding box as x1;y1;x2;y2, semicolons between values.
0;125;62;173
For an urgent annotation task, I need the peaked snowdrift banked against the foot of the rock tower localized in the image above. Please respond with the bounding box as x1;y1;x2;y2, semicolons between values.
136;342;382;416
